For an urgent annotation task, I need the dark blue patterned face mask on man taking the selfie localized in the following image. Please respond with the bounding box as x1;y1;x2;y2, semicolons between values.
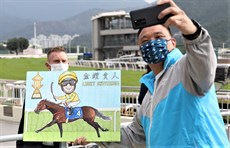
140;39;169;64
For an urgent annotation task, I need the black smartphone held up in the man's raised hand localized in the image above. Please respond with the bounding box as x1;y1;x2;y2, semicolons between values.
130;3;172;29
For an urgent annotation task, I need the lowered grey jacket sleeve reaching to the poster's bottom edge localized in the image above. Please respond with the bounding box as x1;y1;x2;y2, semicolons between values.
97;110;145;148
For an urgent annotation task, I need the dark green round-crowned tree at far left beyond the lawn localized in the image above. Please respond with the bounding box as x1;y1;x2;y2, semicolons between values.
6;37;29;55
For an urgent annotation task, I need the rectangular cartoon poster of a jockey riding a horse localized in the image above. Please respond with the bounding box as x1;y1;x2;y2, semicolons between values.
23;70;121;142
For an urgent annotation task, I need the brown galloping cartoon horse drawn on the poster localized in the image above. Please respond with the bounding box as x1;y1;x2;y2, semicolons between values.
34;99;111;137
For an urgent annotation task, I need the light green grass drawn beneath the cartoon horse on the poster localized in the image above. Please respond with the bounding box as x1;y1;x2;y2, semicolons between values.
24;111;120;141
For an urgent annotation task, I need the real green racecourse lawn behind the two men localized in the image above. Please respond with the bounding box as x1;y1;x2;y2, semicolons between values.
0;58;144;86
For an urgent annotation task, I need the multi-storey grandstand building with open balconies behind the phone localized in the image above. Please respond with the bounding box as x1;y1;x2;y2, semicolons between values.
92;11;139;60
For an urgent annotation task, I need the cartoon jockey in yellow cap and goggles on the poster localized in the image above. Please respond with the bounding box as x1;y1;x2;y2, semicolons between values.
56;71;80;115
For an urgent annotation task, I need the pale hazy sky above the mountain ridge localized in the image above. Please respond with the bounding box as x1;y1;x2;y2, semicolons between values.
0;0;156;21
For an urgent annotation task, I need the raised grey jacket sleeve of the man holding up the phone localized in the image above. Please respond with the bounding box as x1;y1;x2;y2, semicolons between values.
183;21;217;95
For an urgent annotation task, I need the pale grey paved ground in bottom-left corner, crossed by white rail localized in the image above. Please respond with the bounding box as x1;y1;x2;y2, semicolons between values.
0;120;19;148
